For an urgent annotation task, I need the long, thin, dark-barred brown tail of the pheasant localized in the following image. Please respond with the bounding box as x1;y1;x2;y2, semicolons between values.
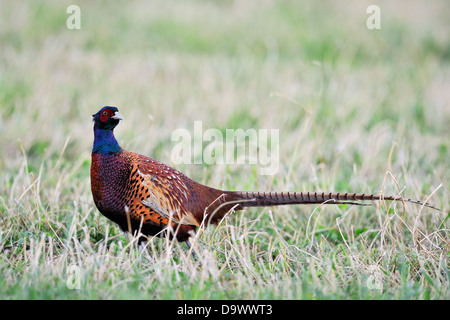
228;191;442;211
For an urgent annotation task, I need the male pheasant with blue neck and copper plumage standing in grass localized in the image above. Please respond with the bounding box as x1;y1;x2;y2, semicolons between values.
91;106;440;242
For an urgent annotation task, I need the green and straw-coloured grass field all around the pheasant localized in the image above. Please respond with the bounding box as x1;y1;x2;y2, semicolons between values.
0;0;450;299
